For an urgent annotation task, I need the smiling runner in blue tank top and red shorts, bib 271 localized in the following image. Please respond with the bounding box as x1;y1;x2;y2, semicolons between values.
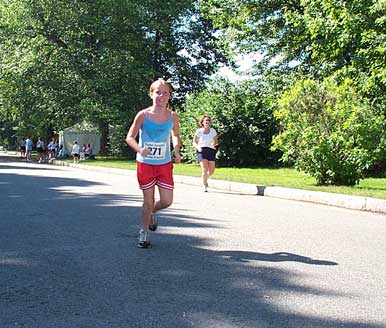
126;79;181;248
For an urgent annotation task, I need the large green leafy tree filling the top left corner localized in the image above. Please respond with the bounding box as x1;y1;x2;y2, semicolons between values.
0;0;148;142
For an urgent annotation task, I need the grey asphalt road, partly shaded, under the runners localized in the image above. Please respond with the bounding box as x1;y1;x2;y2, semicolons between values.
0;157;386;328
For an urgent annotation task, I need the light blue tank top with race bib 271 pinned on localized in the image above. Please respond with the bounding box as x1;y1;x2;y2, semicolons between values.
137;113;173;165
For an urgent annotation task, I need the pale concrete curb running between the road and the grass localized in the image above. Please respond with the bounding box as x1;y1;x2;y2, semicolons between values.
54;161;386;214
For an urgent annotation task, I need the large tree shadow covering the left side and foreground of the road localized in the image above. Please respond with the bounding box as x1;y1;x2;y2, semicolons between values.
0;160;381;328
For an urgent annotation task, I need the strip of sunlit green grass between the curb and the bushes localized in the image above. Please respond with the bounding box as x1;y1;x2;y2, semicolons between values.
67;157;386;199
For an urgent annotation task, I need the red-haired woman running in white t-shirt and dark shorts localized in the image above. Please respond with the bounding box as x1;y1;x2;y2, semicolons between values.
193;115;218;192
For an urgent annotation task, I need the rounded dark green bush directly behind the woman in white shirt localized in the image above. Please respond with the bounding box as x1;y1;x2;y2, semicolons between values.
180;80;277;166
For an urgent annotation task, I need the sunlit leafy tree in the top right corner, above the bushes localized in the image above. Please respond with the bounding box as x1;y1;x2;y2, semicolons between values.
202;0;386;173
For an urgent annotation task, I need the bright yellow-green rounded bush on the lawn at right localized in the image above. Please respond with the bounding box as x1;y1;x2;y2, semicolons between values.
274;79;385;185
